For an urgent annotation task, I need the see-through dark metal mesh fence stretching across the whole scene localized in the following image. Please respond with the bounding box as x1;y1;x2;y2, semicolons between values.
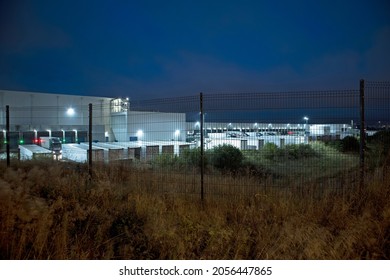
0;82;390;197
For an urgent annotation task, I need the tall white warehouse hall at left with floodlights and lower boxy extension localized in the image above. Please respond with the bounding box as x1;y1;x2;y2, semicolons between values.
0;90;186;149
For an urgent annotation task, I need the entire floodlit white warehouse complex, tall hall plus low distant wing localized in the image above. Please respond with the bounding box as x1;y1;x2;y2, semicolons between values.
0;90;356;162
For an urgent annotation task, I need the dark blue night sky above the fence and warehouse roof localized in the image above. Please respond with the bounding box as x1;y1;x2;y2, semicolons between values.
0;0;390;99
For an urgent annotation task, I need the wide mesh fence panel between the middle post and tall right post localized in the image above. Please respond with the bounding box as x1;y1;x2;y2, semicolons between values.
204;90;359;198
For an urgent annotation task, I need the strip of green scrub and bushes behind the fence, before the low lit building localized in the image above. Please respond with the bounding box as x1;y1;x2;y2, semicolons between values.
152;142;358;178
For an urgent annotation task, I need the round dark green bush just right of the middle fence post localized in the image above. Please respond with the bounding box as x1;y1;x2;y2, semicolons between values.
210;144;244;172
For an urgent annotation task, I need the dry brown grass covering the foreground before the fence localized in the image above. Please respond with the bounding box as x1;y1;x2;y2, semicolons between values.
0;160;390;259
